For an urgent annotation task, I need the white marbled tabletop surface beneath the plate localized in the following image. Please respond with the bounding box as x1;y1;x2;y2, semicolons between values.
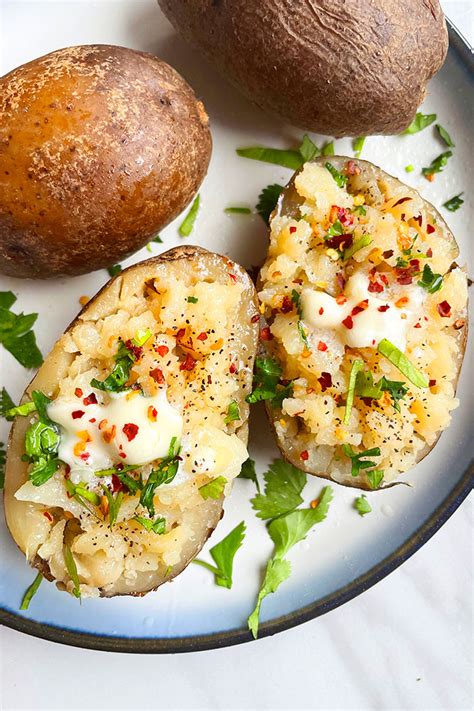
0;0;474;711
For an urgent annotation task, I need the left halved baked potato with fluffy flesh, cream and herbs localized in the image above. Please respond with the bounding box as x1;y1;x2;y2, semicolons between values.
5;247;259;597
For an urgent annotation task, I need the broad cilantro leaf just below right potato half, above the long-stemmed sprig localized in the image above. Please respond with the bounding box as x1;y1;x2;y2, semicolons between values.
251;459;306;520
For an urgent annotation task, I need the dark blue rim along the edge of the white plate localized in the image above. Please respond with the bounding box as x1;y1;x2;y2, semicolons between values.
0;18;474;654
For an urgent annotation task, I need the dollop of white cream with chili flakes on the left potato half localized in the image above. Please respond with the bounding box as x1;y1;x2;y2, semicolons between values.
48;390;183;483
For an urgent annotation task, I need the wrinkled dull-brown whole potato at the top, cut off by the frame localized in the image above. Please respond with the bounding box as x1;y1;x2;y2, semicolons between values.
158;0;448;137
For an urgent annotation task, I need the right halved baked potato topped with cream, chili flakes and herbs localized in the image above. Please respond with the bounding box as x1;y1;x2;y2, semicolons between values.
253;157;467;489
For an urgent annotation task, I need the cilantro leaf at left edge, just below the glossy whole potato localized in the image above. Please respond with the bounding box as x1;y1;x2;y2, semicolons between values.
0;291;43;368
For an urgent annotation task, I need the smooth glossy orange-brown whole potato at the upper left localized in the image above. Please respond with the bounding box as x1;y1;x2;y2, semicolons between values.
0;45;211;278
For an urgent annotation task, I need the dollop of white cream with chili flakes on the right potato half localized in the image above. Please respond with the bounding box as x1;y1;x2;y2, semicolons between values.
301;272;424;351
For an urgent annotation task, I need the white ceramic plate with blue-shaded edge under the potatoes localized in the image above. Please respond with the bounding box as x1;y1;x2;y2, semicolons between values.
0;0;474;652
